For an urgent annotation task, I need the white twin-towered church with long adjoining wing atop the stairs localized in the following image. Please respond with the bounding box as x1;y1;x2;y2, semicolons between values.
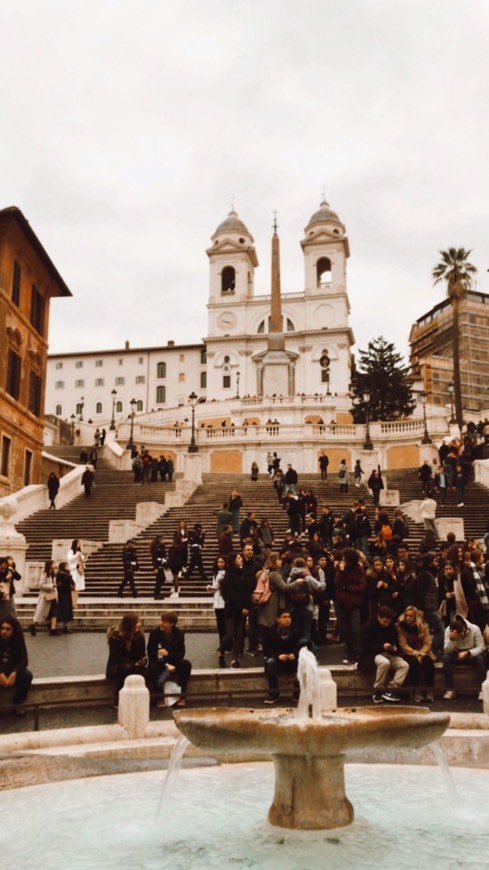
46;201;354;424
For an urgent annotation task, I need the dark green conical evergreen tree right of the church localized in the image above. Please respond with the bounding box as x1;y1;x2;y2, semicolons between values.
351;336;416;423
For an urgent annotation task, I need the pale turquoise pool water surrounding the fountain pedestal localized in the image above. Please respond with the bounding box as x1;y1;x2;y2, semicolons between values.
0;762;489;870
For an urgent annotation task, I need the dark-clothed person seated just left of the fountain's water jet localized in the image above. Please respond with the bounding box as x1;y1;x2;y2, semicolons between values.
263;610;306;704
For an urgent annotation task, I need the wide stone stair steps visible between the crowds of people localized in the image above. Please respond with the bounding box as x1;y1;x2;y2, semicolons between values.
17;464;489;630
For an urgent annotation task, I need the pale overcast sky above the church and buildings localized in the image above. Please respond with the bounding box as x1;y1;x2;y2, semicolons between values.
0;0;489;362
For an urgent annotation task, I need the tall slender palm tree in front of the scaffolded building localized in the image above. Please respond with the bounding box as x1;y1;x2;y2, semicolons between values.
432;248;477;429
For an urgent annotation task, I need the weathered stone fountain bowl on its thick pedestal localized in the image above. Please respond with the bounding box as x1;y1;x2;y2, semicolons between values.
174;706;450;830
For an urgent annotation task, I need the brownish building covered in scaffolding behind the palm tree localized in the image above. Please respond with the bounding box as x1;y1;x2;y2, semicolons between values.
409;290;489;413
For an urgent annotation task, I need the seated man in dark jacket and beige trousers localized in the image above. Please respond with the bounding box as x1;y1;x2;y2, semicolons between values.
358;606;409;704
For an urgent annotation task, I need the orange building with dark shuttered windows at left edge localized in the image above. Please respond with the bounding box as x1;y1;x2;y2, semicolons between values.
0;206;71;495
